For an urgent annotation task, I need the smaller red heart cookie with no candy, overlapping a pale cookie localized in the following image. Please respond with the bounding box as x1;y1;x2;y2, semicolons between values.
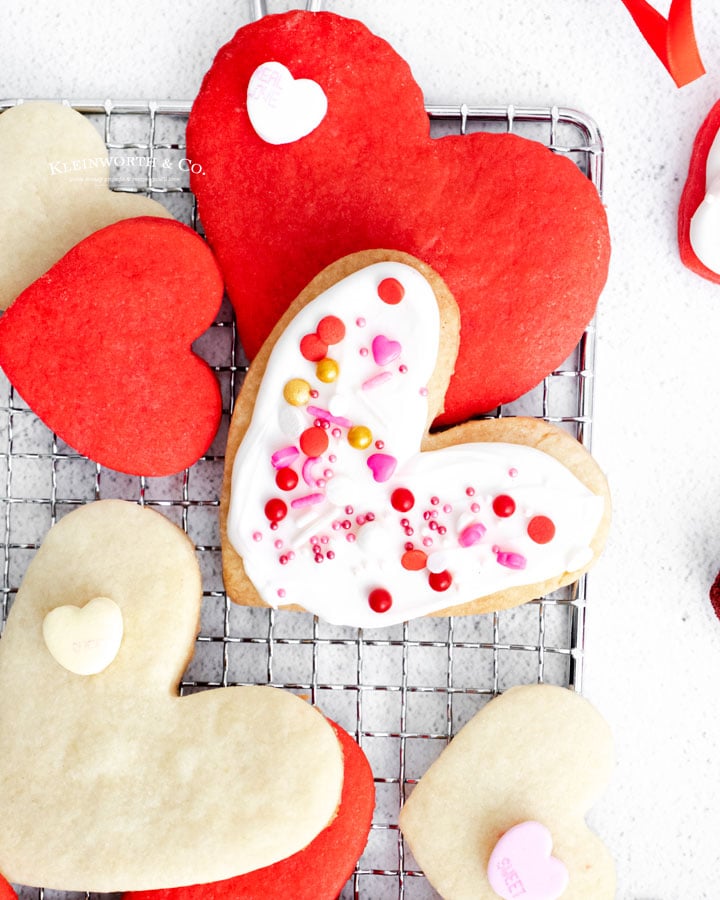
0;217;223;475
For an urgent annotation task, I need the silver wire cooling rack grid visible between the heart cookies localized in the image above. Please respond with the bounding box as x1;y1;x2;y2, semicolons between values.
0;100;603;900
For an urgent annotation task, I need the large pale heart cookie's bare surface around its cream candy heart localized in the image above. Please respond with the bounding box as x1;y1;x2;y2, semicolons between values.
0;500;343;892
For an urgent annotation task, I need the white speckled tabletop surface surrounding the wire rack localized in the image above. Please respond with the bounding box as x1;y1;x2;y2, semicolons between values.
0;0;720;900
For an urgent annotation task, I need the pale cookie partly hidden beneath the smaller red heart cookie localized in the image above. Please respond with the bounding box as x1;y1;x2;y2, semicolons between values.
0;101;170;309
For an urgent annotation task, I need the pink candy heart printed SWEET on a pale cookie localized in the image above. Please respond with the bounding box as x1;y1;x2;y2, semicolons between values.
488;821;568;900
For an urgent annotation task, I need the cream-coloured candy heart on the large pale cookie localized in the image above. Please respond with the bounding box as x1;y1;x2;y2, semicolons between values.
43;597;123;675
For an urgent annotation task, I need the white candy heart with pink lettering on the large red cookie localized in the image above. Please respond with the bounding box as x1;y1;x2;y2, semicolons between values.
247;62;327;144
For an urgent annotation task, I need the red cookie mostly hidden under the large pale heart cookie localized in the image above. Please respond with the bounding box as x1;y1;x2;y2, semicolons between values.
123;723;375;900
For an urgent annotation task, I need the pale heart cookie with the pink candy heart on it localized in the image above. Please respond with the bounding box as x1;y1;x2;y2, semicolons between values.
400;684;615;900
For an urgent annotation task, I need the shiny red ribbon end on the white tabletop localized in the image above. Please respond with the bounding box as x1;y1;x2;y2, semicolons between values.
622;0;705;87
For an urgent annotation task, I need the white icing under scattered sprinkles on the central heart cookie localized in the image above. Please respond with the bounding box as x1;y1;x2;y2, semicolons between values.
227;262;604;627
